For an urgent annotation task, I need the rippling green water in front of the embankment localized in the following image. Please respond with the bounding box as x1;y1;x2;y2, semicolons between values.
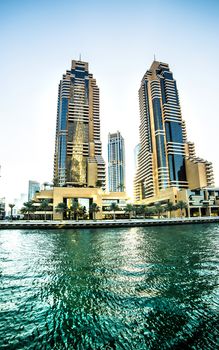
0;224;219;350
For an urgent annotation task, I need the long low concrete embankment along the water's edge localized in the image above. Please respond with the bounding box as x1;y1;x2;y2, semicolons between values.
0;216;219;229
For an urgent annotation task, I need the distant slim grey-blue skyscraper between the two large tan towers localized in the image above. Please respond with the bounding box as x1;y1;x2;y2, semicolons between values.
108;131;125;192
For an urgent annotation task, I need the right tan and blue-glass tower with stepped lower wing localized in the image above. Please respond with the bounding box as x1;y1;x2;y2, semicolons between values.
134;61;214;201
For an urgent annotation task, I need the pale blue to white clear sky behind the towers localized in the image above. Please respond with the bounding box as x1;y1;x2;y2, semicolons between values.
0;0;219;202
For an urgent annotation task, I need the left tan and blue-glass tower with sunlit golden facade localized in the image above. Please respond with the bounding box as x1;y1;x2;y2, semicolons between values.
54;61;105;189
